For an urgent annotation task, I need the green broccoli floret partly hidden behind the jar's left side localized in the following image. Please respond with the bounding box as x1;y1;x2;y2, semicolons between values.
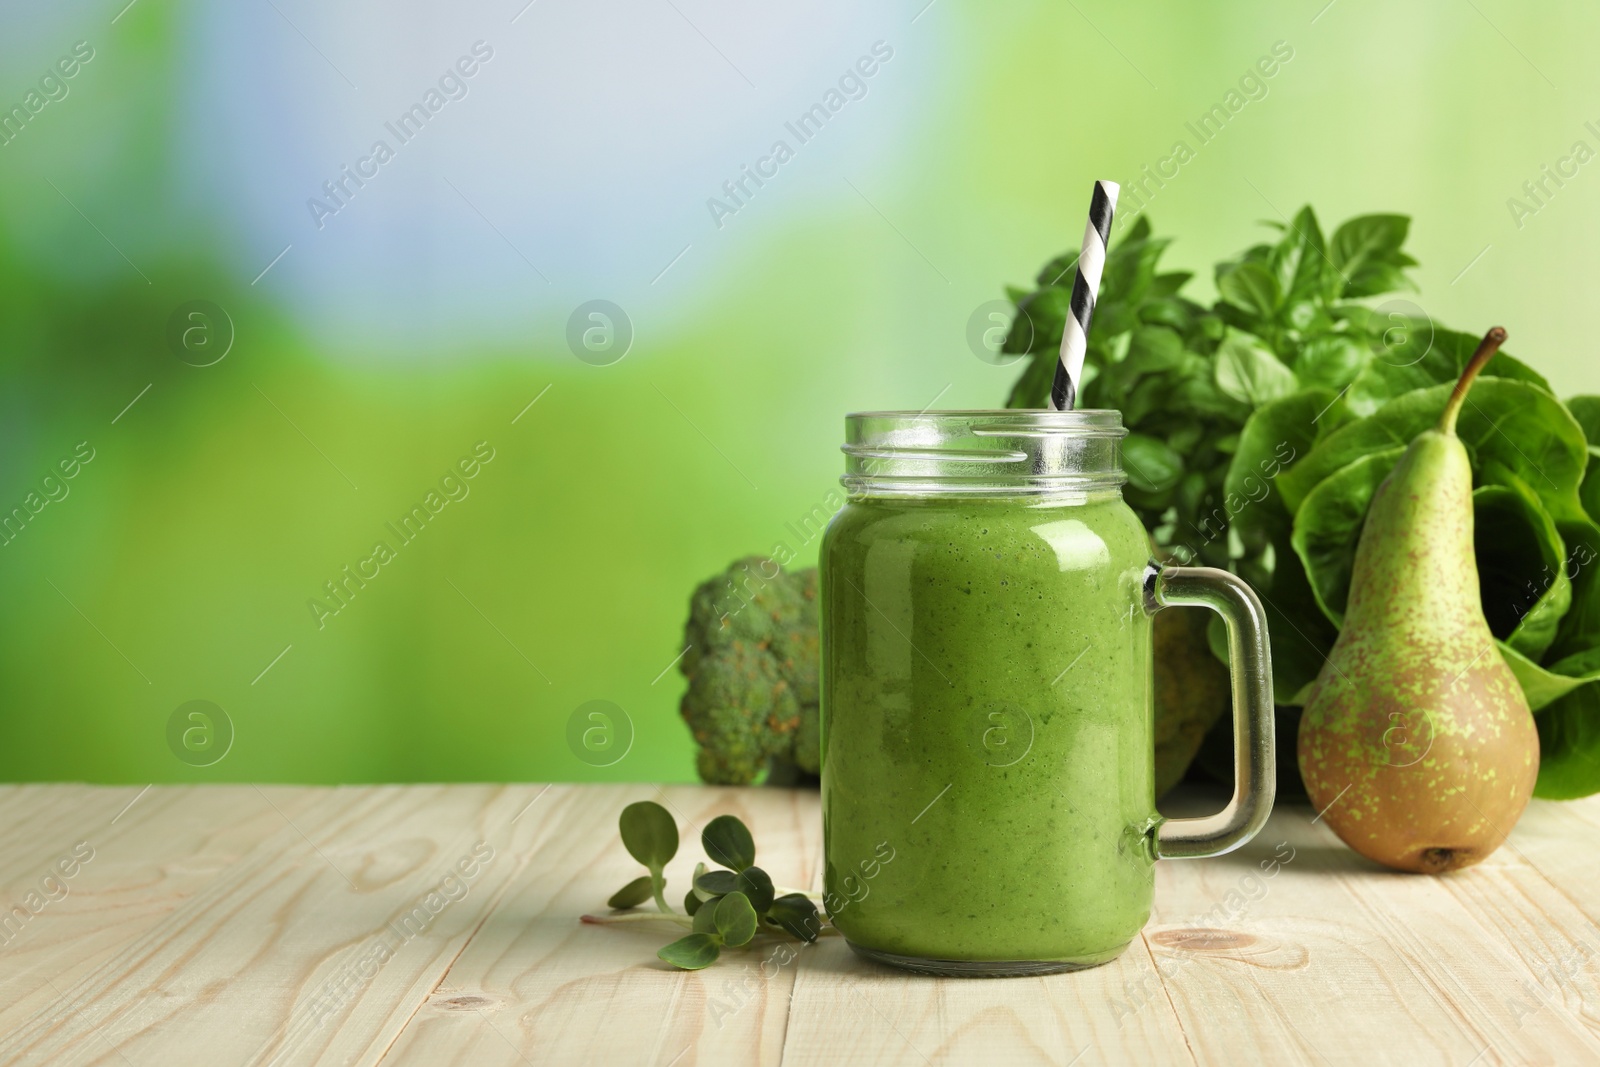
678;557;821;785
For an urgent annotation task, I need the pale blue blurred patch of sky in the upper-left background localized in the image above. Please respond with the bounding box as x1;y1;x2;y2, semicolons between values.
179;0;926;358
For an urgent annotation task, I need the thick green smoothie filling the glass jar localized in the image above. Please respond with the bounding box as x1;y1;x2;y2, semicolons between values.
822;491;1158;966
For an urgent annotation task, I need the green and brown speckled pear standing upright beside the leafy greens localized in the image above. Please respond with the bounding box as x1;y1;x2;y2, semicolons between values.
1299;326;1539;873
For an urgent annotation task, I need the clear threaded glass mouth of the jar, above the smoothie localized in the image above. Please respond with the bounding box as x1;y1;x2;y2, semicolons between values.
840;408;1128;496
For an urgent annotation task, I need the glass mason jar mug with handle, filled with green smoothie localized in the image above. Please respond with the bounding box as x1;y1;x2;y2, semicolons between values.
821;411;1274;976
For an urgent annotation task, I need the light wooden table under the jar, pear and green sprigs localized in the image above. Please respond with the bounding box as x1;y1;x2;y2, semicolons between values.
0;785;1600;1067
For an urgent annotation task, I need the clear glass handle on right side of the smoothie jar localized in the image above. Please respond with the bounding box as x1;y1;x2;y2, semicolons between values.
1144;566;1277;859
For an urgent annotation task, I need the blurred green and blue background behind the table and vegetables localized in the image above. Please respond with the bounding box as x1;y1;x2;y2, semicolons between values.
0;0;1600;782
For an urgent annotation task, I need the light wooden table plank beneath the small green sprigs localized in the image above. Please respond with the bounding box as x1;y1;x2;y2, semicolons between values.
384;785;821;1067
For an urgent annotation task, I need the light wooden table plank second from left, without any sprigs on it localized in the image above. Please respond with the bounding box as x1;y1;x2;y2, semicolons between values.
0;787;553;1064
